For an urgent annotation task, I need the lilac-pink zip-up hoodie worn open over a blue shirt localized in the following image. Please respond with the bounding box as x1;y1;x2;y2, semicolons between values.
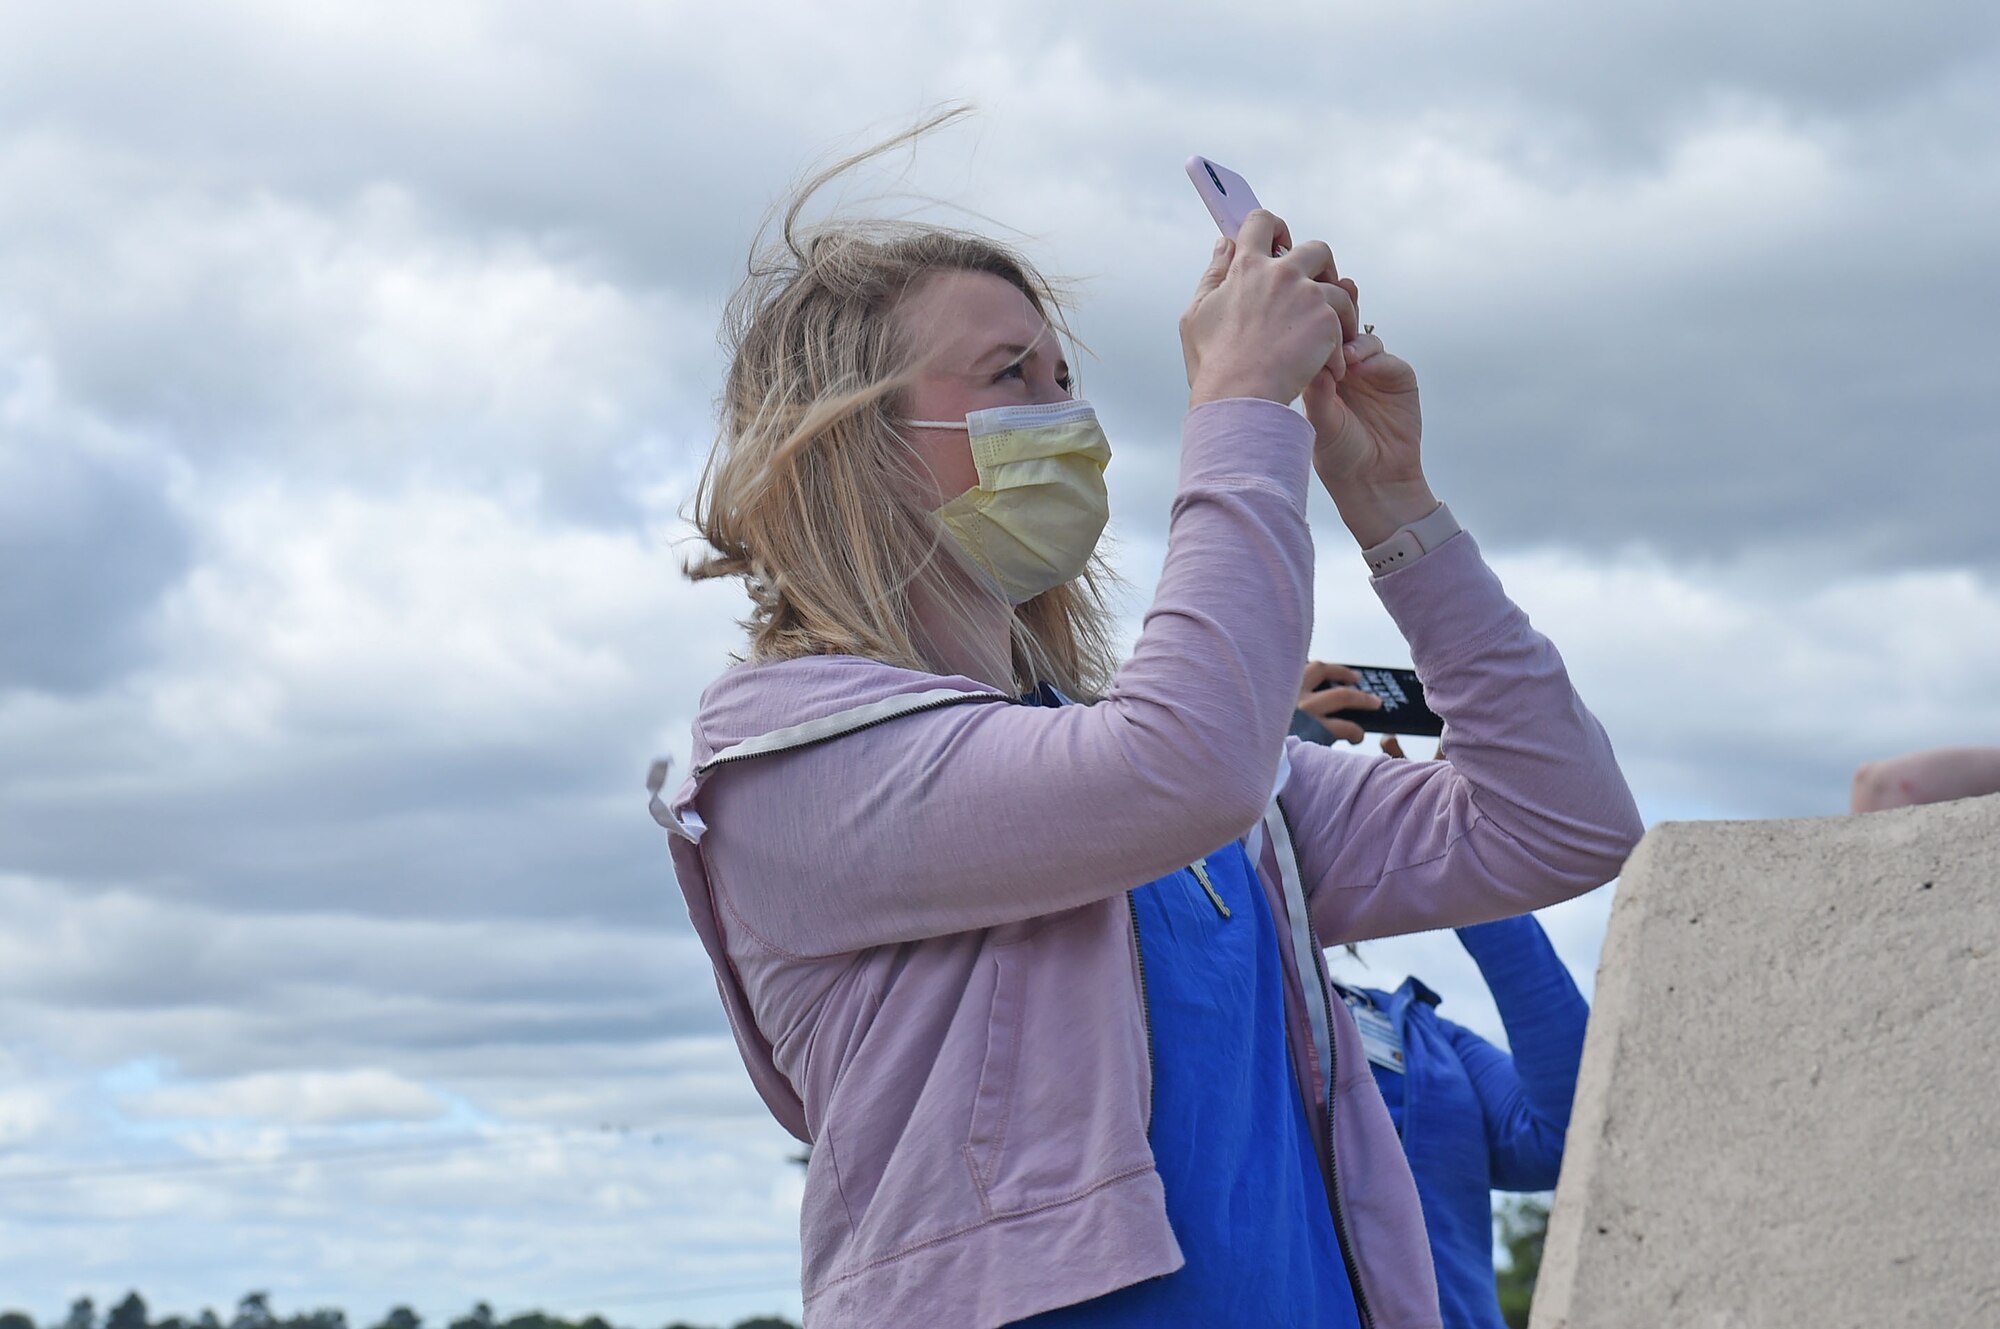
656;400;1642;1329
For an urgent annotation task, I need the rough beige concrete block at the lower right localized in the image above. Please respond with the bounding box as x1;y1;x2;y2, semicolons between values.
1532;797;2000;1329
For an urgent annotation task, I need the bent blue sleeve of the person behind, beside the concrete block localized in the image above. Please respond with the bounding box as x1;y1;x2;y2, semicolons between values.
1446;915;1590;1191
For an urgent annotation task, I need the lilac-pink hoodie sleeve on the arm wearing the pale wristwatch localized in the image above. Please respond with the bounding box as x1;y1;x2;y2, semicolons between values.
1282;534;1644;945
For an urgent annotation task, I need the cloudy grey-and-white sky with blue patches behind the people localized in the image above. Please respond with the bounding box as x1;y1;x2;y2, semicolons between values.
0;0;2000;1325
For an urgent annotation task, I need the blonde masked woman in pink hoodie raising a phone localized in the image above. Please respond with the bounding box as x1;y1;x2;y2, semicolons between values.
654;124;1640;1329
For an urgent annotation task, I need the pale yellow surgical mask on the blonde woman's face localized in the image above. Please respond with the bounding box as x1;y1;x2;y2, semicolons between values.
910;400;1112;604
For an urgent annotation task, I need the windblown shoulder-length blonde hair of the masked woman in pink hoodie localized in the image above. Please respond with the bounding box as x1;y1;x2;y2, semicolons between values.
686;110;1114;699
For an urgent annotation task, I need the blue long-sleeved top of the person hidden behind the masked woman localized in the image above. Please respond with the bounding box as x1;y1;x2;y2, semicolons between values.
1364;917;1590;1329
